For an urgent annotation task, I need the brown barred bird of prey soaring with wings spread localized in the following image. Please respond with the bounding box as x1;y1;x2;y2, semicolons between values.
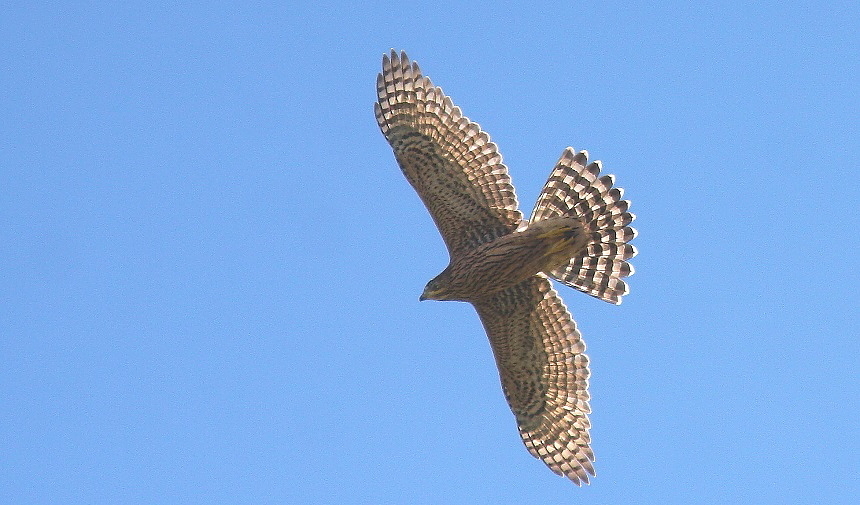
374;50;636;485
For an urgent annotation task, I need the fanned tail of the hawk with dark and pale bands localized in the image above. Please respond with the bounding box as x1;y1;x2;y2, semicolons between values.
529;147;637;305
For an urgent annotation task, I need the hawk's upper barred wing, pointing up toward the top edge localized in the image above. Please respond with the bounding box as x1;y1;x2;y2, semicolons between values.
374;50;522;258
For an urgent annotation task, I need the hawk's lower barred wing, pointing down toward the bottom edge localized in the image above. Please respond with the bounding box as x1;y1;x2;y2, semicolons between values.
474;274;595;485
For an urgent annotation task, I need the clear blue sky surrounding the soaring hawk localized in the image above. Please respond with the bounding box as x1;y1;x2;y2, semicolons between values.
0;1;860;505
